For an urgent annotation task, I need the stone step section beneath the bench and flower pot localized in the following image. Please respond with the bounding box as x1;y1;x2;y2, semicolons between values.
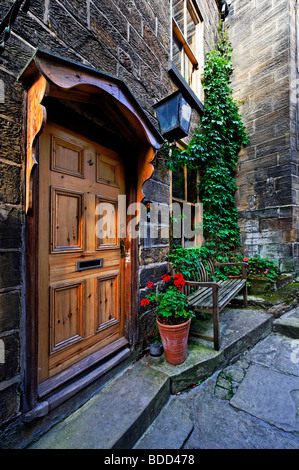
145;308;273;394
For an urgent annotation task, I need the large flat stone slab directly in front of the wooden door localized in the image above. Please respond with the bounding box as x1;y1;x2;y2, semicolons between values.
31;363;170;449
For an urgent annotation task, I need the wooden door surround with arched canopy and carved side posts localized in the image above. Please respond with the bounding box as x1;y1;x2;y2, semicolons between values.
19;52;163;412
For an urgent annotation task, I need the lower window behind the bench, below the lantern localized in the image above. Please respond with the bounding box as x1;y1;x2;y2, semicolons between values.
171;149;202;248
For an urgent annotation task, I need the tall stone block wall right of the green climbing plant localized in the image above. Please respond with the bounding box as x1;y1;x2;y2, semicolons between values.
227;0;299;271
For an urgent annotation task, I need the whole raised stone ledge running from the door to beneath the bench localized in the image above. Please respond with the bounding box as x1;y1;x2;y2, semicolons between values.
30;309;272;449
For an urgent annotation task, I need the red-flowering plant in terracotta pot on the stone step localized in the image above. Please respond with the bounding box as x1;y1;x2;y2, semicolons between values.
141;273;194;365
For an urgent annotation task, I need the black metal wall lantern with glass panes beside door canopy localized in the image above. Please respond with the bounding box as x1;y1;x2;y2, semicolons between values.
154;90;192;142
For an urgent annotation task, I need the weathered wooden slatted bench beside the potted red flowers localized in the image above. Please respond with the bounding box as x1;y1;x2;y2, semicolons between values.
170;260;247;351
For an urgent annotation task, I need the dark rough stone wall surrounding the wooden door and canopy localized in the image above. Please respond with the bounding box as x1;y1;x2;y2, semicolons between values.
0;0;219;442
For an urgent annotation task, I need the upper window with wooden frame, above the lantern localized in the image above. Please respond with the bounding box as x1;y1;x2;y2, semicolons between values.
171;0;203;99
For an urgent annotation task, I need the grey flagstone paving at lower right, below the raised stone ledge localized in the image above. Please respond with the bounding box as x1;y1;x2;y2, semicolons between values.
141;324;299;450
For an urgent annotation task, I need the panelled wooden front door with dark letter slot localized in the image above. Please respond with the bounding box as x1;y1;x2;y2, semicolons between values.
37;124;125;383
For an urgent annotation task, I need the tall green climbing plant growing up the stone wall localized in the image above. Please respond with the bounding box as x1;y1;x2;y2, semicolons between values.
169;26;249;252
